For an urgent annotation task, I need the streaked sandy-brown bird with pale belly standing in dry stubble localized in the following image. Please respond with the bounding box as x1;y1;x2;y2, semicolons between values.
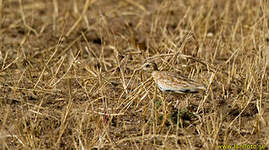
143;62;206;94
